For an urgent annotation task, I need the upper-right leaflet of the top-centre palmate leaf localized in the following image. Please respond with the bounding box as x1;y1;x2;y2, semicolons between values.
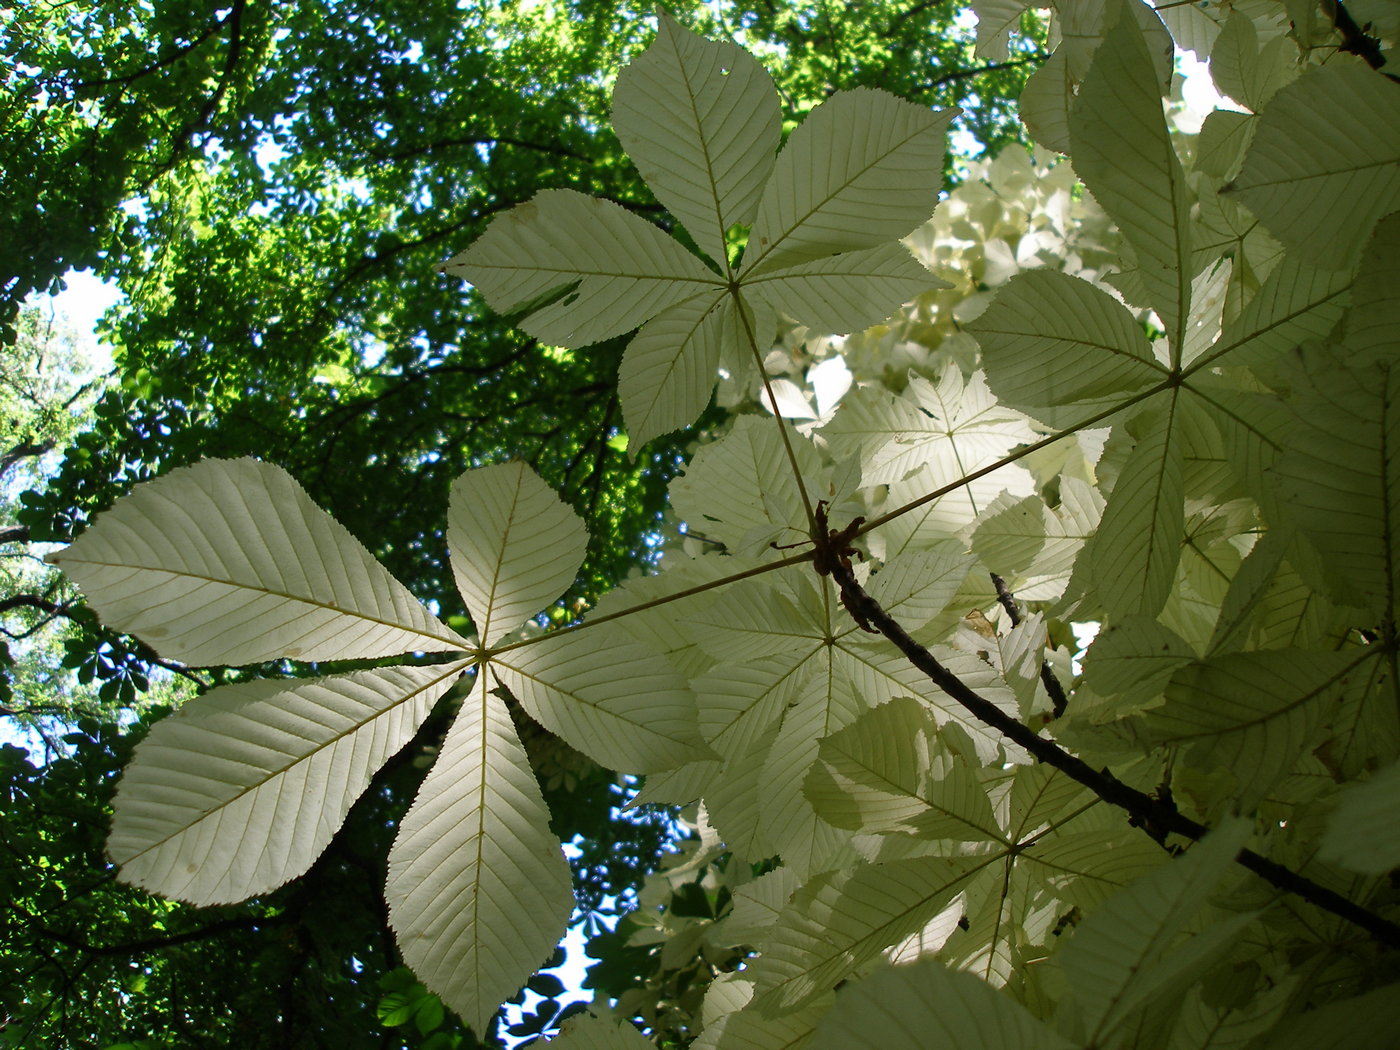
742;88;960;280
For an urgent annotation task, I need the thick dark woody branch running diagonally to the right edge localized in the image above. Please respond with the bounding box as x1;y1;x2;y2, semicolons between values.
830;559;1400;948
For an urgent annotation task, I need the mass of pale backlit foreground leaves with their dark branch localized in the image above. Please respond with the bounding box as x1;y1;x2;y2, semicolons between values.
24;0;1400;1050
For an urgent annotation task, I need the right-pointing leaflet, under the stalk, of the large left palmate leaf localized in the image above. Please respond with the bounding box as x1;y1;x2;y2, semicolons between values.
491;624;710;773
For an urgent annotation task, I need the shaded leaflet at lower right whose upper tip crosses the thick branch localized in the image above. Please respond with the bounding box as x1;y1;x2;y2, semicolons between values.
1057;818;1254;1046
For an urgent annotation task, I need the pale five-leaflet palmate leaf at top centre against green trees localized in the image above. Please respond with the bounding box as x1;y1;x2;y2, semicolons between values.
442;14;958;448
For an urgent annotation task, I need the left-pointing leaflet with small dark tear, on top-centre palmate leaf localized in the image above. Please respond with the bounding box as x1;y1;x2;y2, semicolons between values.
442;189;722;347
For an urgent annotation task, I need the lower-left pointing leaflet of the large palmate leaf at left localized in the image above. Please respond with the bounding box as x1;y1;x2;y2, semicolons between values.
108;661;468;904
